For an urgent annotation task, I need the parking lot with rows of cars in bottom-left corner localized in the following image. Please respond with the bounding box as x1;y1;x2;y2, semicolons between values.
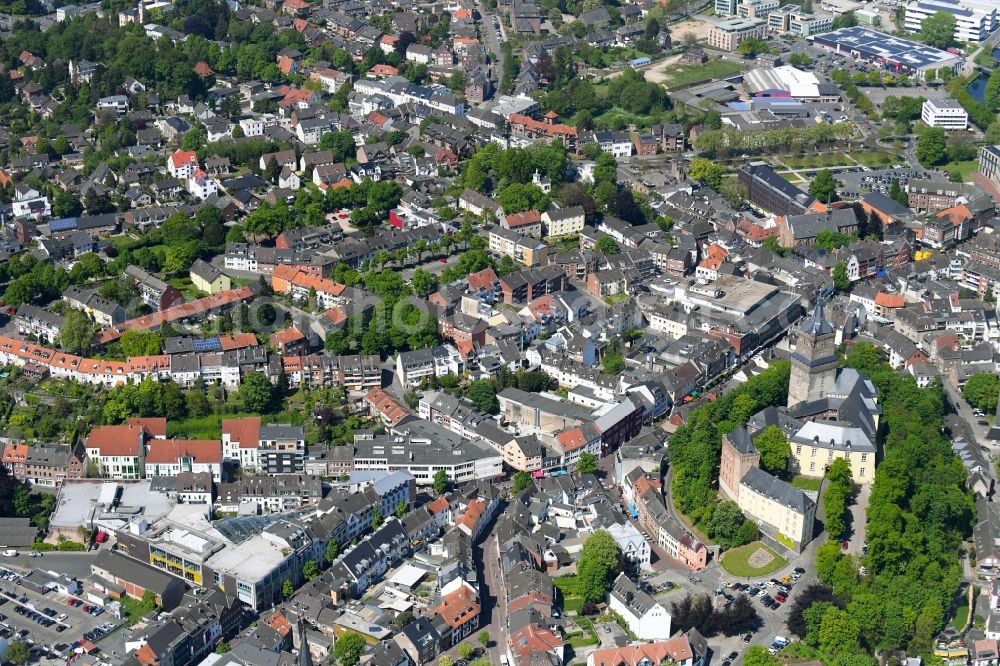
0;567;118;657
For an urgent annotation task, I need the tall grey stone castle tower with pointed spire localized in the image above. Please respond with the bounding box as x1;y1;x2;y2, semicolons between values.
788;299;837;407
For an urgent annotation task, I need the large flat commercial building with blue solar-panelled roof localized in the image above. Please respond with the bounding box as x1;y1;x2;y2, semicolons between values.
809;25;962;78
